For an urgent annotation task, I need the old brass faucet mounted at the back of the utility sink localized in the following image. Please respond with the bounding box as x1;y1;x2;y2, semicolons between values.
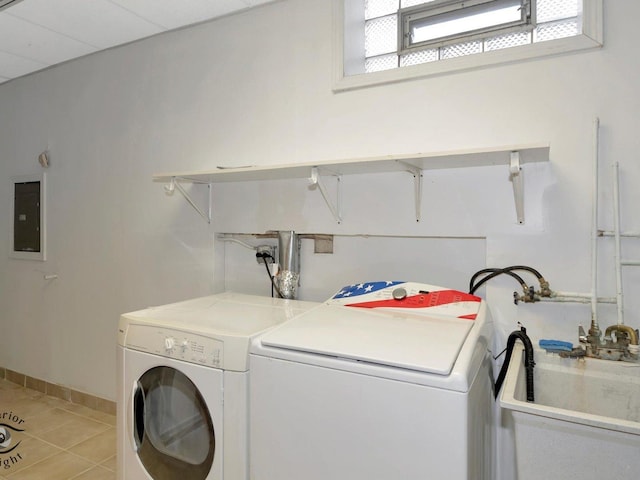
578;319;640;362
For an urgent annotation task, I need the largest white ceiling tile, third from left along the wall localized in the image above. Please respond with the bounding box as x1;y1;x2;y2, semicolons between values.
6;0;163;49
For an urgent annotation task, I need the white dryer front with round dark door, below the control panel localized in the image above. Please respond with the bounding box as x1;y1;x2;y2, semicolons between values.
124;351;223;480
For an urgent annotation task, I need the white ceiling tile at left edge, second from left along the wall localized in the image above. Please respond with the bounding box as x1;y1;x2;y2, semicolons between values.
0;15;96;64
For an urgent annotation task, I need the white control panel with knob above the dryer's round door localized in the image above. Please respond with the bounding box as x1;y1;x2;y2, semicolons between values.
125;324;224;368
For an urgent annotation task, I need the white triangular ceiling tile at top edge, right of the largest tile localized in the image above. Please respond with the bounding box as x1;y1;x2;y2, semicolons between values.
106;0;254;30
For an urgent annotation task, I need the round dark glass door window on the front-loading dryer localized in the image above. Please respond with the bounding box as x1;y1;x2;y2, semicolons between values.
133;366;215;480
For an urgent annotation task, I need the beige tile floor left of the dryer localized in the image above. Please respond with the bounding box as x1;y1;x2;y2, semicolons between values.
0;380;116;480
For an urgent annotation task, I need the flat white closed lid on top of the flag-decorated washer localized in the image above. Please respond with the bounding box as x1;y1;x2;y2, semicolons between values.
260;305;474;375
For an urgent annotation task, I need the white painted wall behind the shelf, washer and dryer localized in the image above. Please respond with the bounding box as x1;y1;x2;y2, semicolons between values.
0;0;640;438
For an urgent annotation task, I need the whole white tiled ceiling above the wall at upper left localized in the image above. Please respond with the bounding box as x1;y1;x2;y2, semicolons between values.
0;0;274;83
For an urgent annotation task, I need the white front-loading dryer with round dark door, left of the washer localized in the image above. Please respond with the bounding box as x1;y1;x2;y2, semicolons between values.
117;293;317;480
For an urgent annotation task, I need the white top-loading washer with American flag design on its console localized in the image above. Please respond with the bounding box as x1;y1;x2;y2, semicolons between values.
249;282;493;480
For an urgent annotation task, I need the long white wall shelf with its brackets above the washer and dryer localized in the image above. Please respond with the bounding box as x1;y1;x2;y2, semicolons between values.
153;144;549;224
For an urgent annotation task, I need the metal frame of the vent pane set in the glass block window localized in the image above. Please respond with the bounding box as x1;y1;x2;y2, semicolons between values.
397;0;536;55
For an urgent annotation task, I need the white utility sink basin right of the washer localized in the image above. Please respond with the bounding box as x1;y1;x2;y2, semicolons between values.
500;344;640;480
